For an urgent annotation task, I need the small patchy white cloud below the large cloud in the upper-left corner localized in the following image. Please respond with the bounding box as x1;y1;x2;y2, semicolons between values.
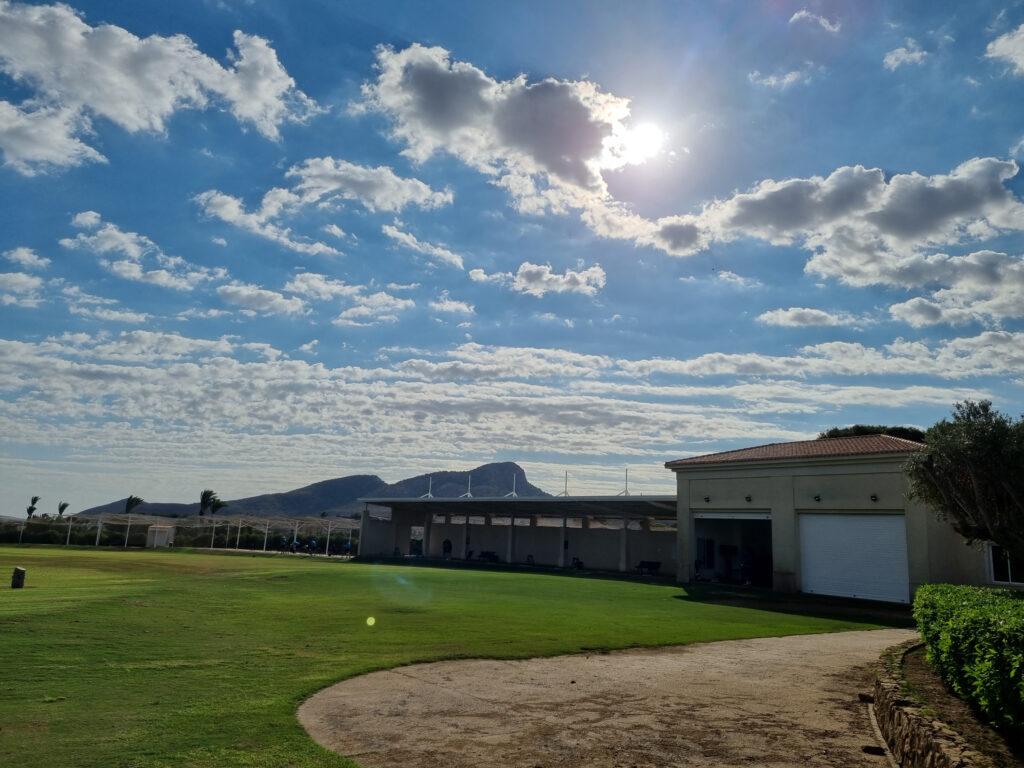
59;211;227;291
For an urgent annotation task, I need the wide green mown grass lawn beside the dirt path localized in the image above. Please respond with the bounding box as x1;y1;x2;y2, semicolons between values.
0;547;905;768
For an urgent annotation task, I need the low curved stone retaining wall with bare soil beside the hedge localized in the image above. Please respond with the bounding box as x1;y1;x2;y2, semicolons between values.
874;640;989;768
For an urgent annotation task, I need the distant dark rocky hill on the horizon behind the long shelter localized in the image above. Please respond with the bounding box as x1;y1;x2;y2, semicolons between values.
79;462;550;517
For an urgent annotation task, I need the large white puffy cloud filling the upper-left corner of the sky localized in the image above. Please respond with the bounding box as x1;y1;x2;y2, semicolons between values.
0;0;319;175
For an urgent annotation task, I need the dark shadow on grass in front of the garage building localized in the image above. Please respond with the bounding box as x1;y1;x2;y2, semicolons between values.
676;584;914;629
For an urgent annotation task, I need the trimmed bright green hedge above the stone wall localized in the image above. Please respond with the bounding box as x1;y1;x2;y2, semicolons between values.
913;584;1024;730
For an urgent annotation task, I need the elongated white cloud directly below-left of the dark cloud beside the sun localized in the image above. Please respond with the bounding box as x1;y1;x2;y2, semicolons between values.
286;158;453;212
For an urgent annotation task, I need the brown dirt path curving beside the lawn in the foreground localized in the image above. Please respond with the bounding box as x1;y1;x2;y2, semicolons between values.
298;630;913;768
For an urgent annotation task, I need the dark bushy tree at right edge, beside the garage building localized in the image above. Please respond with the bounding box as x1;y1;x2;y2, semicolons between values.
903;400;1024;560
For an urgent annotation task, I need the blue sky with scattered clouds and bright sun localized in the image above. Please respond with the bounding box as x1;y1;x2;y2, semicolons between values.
0;0;1024;514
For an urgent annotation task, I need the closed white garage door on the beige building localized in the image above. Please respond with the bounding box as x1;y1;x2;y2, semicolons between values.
800;514;910;603
